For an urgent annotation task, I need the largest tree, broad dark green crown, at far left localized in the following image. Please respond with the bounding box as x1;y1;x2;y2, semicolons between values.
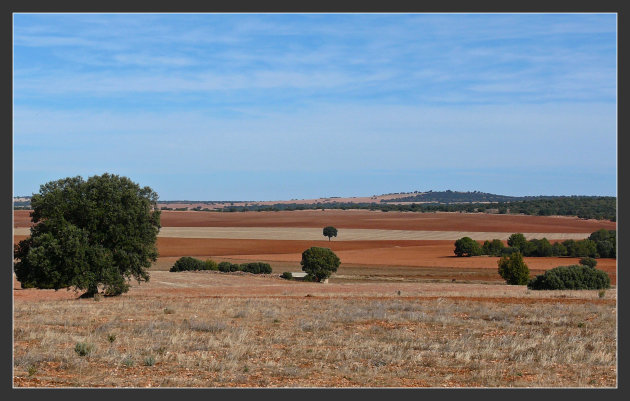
14;173;160;297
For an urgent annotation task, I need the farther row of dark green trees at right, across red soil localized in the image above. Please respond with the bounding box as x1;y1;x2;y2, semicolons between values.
454;229;617;258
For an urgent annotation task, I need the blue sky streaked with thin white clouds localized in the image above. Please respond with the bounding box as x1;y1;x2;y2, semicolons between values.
13;13;617;201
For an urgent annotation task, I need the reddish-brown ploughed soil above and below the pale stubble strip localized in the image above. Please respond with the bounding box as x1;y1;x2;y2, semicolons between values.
14;210;616;284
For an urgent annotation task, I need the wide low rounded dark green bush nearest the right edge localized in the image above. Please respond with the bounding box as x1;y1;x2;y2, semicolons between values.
527;265;610;290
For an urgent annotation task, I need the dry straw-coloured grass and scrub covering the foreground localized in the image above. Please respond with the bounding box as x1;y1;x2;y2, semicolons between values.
14;288;617;387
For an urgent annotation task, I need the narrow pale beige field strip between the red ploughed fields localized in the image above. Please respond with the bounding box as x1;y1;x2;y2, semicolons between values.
158;227;590;241
